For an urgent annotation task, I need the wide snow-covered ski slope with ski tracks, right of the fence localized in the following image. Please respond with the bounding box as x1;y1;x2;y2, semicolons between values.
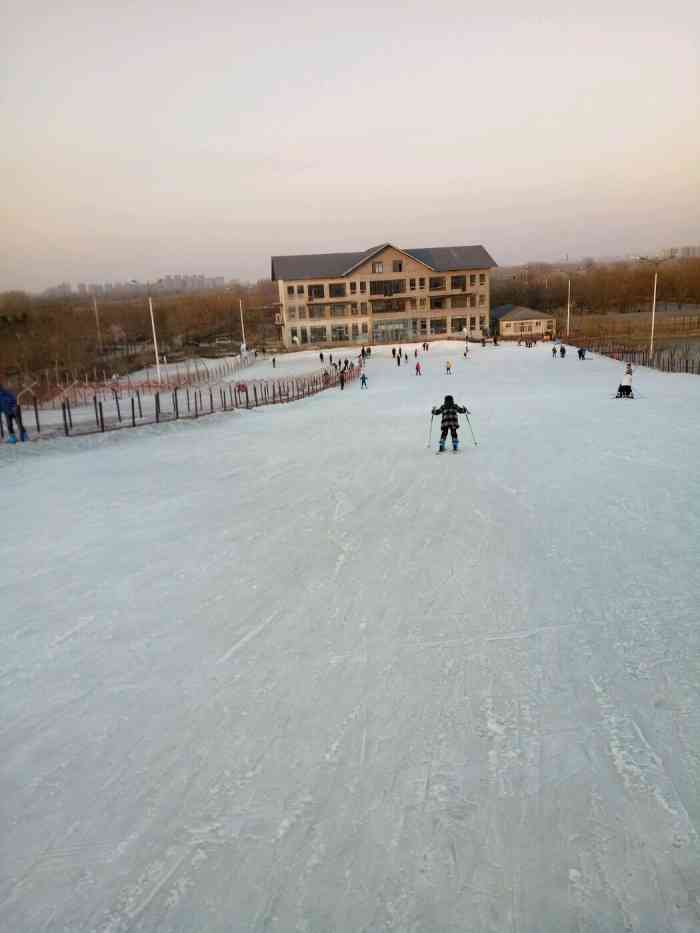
0;344;700;933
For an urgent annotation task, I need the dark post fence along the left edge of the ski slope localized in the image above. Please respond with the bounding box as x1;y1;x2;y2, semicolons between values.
5;364;362;439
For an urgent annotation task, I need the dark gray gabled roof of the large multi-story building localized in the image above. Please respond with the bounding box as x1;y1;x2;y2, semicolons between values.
272;243;496;282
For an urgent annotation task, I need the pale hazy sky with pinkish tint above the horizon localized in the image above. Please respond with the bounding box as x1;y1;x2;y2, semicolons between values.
0;0;700;289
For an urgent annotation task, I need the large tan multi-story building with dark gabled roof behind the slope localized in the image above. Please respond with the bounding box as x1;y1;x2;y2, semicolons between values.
272;243;496;346
